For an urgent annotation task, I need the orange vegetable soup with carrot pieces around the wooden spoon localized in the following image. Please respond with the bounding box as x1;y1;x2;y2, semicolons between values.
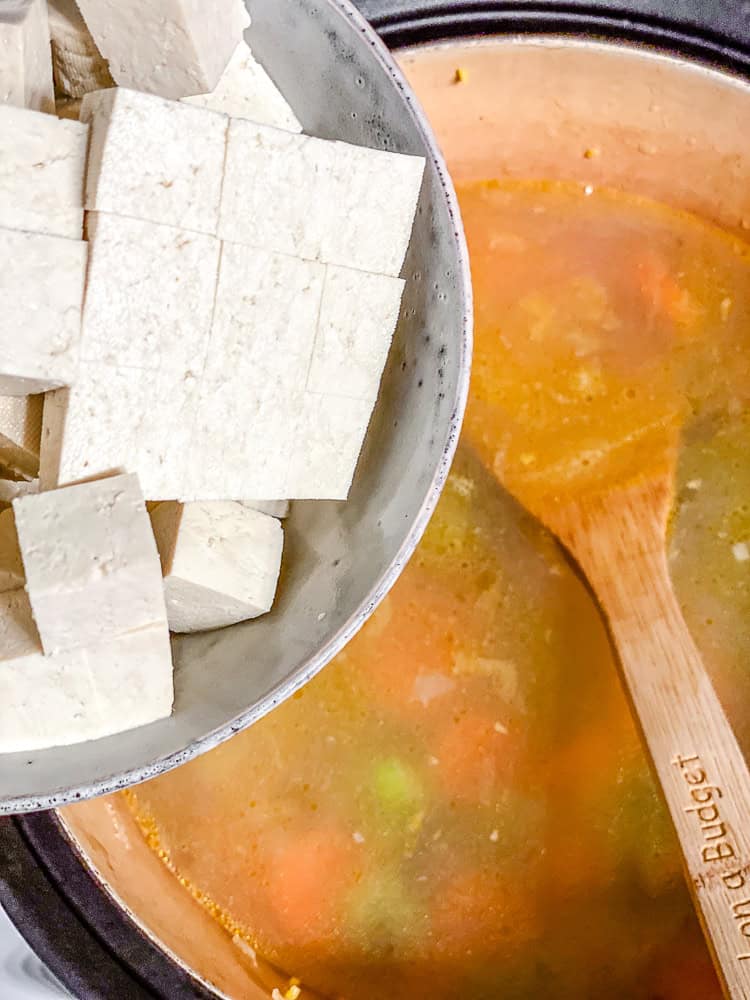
127;182;750;1000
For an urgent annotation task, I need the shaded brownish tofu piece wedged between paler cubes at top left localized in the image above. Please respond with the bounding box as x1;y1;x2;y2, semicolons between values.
49;0;114;98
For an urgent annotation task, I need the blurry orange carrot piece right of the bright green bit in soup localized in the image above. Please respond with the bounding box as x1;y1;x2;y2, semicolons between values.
435;713;518;802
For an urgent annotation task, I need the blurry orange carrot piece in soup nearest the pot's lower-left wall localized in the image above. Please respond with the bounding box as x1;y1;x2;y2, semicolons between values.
268;826;360;945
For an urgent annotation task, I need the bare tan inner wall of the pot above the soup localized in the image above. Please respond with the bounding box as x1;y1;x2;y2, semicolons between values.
61;38;750;998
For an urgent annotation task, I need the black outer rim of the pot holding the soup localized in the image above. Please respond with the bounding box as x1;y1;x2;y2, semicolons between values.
0;0;750;1000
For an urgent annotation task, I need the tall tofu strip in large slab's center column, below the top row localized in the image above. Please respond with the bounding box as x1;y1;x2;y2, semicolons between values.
187;243;325;500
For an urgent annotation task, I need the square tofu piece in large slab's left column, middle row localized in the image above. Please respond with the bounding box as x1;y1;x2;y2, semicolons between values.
81;212;220;373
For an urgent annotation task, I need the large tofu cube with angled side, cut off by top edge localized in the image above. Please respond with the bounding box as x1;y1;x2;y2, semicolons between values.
78;0;250;100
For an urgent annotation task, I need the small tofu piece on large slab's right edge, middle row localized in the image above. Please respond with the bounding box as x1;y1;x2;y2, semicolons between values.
307;265;404;405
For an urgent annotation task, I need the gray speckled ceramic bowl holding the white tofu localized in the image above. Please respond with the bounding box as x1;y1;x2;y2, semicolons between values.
0;0;471;813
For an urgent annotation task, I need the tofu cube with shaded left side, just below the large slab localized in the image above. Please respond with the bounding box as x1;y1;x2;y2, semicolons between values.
151;501;284;632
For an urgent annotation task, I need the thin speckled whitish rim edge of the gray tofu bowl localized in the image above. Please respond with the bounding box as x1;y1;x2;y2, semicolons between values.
0;0;474;815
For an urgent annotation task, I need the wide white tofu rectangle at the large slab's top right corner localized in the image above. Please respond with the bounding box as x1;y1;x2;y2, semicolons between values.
218;119;424;276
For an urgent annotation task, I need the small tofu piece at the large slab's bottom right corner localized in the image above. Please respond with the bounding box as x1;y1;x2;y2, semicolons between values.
286;393;373;500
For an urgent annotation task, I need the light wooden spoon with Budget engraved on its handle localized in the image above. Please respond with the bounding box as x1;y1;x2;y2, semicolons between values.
520;467;750;1000
